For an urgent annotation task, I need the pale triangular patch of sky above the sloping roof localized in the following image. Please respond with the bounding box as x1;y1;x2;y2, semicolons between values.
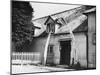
30;2;80;20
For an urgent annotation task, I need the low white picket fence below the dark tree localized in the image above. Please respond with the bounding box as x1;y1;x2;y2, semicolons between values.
12;52;41;65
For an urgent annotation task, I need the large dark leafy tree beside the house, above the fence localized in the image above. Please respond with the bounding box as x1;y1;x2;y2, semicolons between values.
12;1;34;51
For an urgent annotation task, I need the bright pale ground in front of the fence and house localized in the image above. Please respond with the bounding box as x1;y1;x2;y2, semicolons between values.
12;65;72;74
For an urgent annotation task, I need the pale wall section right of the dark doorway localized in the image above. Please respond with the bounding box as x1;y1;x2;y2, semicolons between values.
71;33;87;67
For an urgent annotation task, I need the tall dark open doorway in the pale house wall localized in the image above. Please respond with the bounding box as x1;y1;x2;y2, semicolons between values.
60;40;71;65
